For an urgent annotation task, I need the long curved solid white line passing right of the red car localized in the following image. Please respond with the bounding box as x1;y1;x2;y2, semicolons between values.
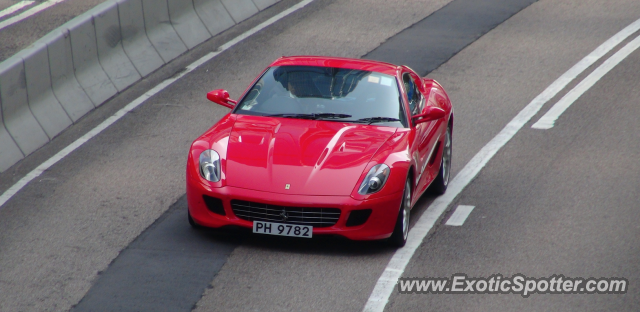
363;19;640;312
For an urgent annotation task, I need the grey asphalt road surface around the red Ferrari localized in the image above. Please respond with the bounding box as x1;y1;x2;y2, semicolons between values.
0;0;640;311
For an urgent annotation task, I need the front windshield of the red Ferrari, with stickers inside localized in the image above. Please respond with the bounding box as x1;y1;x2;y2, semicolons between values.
235;66;407;127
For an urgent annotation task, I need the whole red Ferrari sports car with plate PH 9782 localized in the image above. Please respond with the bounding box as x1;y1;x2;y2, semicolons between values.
187;56;453;246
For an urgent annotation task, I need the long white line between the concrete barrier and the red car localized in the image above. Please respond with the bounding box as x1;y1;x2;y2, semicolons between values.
0;0;313;207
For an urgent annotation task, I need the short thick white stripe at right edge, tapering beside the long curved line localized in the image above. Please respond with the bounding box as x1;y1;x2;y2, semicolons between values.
531;37;640;130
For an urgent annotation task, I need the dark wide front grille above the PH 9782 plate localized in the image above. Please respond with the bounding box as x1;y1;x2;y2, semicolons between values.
231;199;340;227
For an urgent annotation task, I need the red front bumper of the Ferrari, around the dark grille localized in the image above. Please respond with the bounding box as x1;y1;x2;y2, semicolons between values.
187;177;402;240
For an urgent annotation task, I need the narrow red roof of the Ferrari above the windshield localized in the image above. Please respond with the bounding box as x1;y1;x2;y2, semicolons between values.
270;56;399;76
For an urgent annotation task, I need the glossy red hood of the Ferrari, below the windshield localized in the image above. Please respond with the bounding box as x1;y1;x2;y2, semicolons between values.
226;115;397;196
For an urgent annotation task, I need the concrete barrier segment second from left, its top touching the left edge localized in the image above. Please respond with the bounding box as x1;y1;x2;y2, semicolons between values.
0;55;49;155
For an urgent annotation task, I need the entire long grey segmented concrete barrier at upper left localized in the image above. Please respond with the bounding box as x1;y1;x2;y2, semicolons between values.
0;0;280;173
